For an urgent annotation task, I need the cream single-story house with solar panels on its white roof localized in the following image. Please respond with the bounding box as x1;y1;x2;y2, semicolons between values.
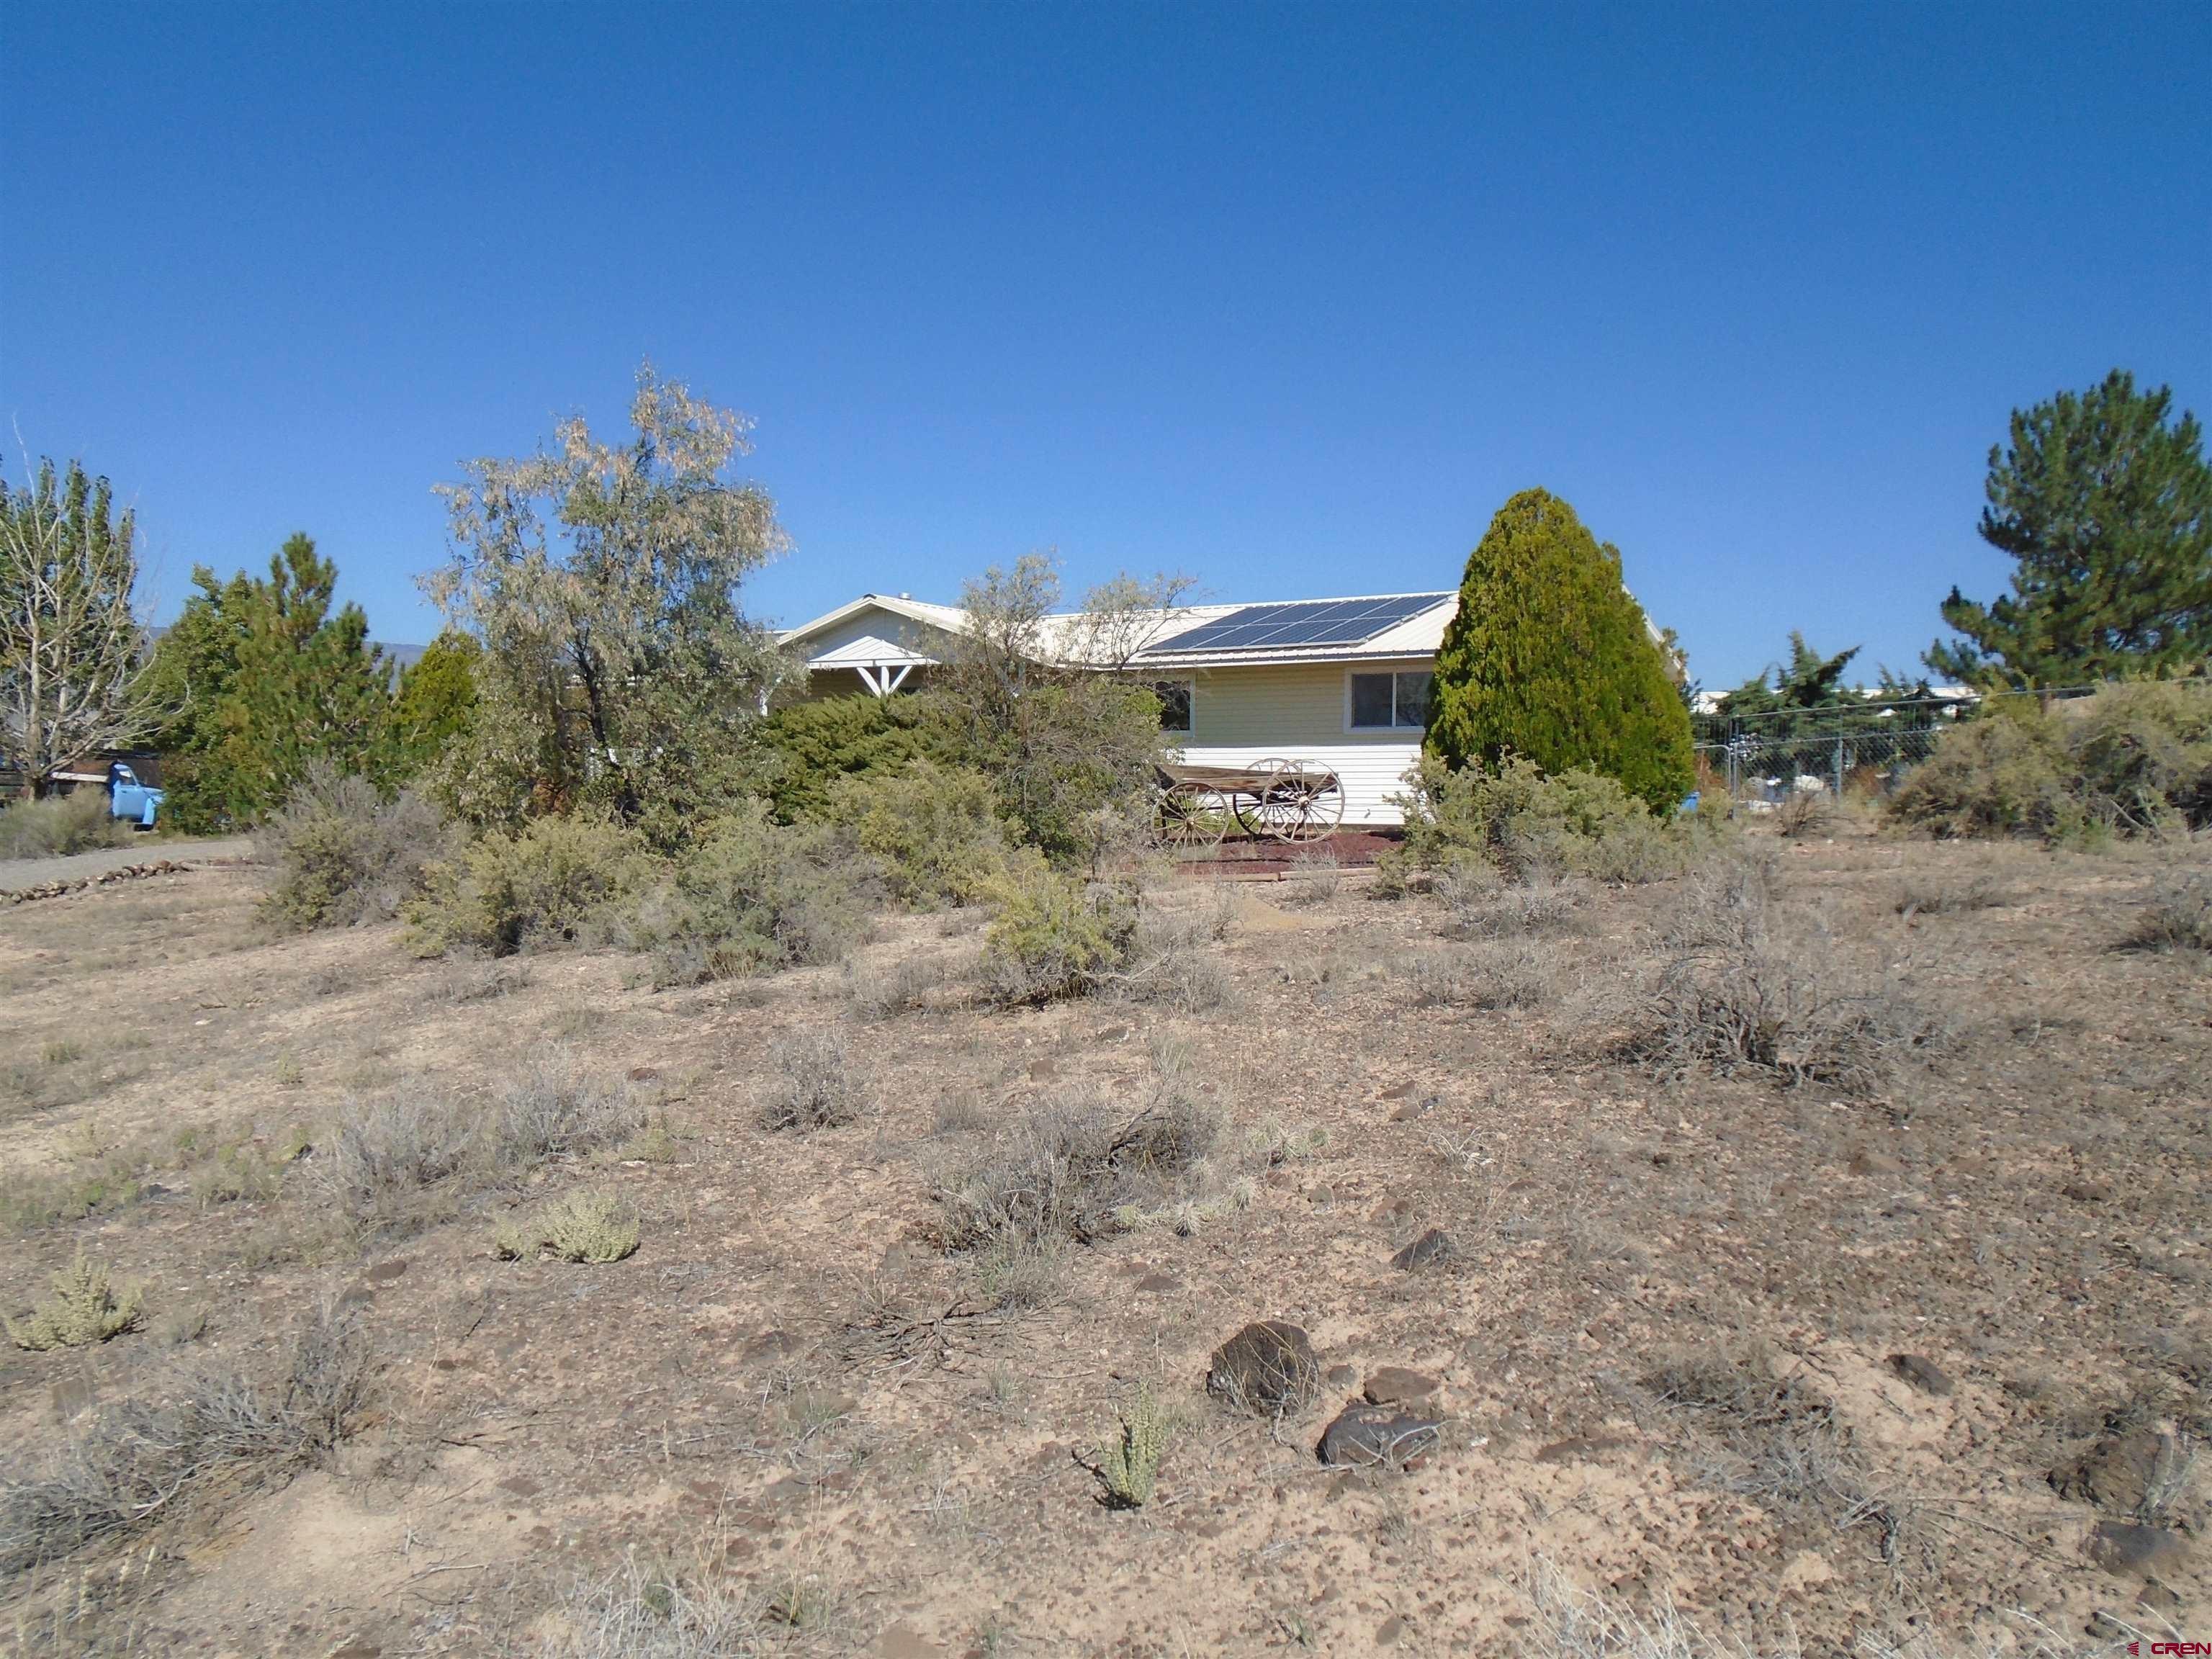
783;590;1460;825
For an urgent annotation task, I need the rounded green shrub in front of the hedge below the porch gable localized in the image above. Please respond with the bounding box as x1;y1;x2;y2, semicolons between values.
830;761;1007;909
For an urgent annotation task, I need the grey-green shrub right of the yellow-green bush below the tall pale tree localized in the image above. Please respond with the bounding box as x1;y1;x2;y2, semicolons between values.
617;803;869;986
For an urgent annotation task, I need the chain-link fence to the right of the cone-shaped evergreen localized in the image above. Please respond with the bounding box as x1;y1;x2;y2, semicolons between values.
1692;681;2185;801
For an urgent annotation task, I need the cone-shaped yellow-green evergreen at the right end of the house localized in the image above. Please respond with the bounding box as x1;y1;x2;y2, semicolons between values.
1426;489;1692;809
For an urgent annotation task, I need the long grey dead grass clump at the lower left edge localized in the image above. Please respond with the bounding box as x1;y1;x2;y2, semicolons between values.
0;1308;372;1573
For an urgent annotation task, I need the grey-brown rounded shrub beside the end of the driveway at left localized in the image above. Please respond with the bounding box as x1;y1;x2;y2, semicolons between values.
256;761;451;927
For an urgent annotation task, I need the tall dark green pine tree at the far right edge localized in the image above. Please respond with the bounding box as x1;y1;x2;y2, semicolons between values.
1927;369;2212;688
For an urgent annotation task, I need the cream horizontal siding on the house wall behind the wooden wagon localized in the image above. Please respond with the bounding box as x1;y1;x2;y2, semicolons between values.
1184;657;1429;825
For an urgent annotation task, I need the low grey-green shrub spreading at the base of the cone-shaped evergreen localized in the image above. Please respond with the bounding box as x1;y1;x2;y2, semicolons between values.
1385;755;1721;883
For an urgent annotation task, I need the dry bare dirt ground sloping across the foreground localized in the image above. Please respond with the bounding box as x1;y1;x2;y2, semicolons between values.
0;830;2212;1659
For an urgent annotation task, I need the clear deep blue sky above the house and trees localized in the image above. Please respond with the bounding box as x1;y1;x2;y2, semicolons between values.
0;0;2212;683
